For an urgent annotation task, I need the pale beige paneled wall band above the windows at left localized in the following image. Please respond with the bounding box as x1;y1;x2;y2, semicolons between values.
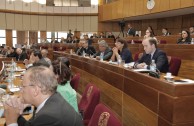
0;13;98;32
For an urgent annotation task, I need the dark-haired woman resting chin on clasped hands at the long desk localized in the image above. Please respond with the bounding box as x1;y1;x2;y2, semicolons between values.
111;38;133;63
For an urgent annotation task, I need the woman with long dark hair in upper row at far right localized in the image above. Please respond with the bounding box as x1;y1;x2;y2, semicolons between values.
177;30;191;44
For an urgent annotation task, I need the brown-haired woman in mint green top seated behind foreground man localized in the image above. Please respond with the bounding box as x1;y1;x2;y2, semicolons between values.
53;62;78;112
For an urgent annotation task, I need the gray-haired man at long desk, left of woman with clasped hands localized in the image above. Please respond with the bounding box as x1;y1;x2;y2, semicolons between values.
94;40;113;60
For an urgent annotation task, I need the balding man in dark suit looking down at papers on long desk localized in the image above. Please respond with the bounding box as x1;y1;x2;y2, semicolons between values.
134;38;169;73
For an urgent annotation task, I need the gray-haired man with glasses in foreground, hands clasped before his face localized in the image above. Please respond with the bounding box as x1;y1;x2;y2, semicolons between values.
4;66;83;126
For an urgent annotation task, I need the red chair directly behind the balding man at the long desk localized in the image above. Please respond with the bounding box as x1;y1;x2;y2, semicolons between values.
168;56;181;76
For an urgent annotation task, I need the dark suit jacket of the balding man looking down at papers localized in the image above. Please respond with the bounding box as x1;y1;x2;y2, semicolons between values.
137;49;169;73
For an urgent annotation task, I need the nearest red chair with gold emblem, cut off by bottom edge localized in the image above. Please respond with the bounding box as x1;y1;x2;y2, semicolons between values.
88;104;122;126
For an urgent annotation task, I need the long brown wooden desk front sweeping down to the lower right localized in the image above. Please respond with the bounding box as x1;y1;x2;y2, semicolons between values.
54;52;194;126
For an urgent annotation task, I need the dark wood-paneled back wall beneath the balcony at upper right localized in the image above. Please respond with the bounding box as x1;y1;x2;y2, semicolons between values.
98;14;194;35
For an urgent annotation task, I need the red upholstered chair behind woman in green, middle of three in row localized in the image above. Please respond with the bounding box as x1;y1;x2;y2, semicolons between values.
78;84;100;126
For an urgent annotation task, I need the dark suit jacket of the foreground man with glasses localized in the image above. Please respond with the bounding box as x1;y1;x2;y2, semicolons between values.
18;93;83;126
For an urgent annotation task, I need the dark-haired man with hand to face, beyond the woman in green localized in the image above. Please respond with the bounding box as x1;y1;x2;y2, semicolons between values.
24;50;50;68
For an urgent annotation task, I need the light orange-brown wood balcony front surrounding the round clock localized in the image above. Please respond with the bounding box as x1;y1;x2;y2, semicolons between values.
99;0;194;21
